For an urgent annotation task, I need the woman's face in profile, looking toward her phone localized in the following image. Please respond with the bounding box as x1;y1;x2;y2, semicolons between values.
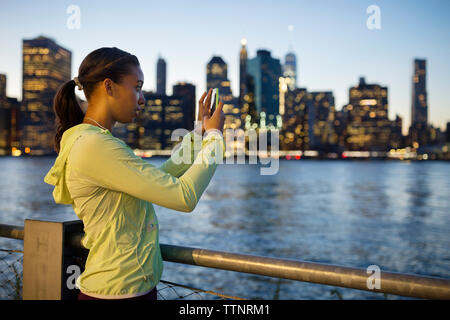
111;66;145;123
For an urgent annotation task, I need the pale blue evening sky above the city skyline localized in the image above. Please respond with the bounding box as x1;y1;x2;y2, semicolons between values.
0;0;450;132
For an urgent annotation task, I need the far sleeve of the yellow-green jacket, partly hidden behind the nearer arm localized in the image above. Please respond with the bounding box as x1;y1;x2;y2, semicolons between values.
159;131;202;178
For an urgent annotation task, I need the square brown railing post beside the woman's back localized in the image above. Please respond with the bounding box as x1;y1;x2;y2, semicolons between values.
23;219;83;300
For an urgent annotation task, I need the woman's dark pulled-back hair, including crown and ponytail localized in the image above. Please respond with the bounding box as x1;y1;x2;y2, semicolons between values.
53;47;139;153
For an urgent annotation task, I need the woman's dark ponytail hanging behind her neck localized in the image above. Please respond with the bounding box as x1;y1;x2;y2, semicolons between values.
53;80;84;153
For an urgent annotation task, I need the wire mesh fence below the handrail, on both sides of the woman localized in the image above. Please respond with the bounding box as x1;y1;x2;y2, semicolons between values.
0;249;243;300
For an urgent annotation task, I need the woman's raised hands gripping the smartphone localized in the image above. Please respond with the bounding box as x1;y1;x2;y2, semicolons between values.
197;89;225;133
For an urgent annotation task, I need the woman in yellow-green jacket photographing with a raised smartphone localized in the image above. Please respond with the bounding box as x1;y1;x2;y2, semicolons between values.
44;48;224;300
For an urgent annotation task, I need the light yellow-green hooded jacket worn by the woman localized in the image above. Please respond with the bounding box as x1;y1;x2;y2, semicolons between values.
44;123;224;299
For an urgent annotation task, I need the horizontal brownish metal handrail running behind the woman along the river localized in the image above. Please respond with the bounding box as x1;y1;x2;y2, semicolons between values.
0;225;450;299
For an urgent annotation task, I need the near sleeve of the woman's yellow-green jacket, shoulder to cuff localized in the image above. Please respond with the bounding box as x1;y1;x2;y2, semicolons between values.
68;132;224;212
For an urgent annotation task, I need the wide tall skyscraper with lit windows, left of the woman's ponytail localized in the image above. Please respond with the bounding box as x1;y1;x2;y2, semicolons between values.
20;36;72;155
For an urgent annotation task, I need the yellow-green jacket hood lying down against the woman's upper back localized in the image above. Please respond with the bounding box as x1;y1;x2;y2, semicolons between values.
44;123;111;204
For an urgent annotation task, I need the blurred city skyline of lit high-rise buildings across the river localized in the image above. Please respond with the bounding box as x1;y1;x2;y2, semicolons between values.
0;36;449;160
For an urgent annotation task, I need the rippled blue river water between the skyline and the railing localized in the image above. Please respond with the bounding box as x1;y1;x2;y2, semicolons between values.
0;157;450;299
